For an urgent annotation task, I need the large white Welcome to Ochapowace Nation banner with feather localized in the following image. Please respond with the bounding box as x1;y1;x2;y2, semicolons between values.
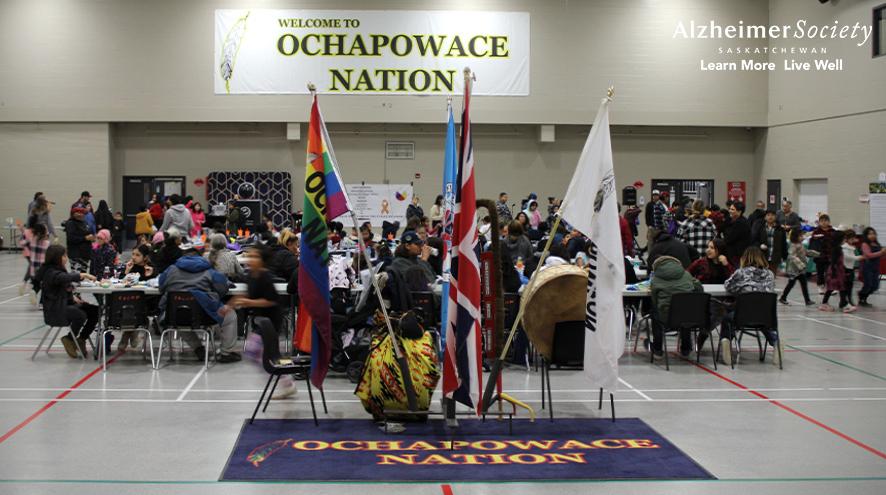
213;9;529;96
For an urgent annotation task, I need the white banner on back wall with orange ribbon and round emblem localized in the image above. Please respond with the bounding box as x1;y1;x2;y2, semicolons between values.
338;184;412;228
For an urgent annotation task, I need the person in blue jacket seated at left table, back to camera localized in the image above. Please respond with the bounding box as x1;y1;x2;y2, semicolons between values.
159;249;240;363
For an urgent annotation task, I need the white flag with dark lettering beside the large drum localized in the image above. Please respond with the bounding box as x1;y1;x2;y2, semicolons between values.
560;98;625;392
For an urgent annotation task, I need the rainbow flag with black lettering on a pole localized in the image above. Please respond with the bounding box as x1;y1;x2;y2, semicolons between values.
295;94;350;388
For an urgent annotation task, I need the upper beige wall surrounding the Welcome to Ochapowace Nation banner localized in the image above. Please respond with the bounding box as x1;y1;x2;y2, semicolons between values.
0;0;768;126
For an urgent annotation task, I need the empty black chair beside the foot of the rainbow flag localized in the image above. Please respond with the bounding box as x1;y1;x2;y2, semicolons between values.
249;320;329;426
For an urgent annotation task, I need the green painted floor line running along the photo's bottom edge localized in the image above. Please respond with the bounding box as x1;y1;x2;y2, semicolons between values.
0;476;886;485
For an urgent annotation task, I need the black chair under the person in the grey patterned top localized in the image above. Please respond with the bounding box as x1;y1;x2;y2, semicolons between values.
717;292;784;369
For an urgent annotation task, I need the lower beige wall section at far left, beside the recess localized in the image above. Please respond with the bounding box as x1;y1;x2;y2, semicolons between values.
0;123;111;232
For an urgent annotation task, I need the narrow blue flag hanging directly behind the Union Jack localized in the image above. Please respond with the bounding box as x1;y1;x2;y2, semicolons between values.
440;104;458;359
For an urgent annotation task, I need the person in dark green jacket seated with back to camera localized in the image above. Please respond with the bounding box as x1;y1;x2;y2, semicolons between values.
645;256;707;357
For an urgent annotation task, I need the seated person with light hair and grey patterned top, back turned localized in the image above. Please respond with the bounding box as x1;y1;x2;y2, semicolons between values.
720;246;783;366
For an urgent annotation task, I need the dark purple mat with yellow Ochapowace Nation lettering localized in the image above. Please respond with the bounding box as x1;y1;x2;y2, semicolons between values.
221;418;713;481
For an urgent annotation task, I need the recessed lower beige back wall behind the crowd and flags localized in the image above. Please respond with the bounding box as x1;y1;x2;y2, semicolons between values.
113;124;754;220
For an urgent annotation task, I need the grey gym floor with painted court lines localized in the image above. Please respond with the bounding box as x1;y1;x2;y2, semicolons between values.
0;253;886;495
